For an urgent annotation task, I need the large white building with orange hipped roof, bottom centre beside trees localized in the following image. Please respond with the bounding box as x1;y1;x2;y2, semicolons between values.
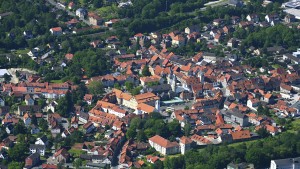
149;135;180;155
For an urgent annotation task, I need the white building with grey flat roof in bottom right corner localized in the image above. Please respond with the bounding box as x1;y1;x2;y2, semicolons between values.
270;157;300;169
